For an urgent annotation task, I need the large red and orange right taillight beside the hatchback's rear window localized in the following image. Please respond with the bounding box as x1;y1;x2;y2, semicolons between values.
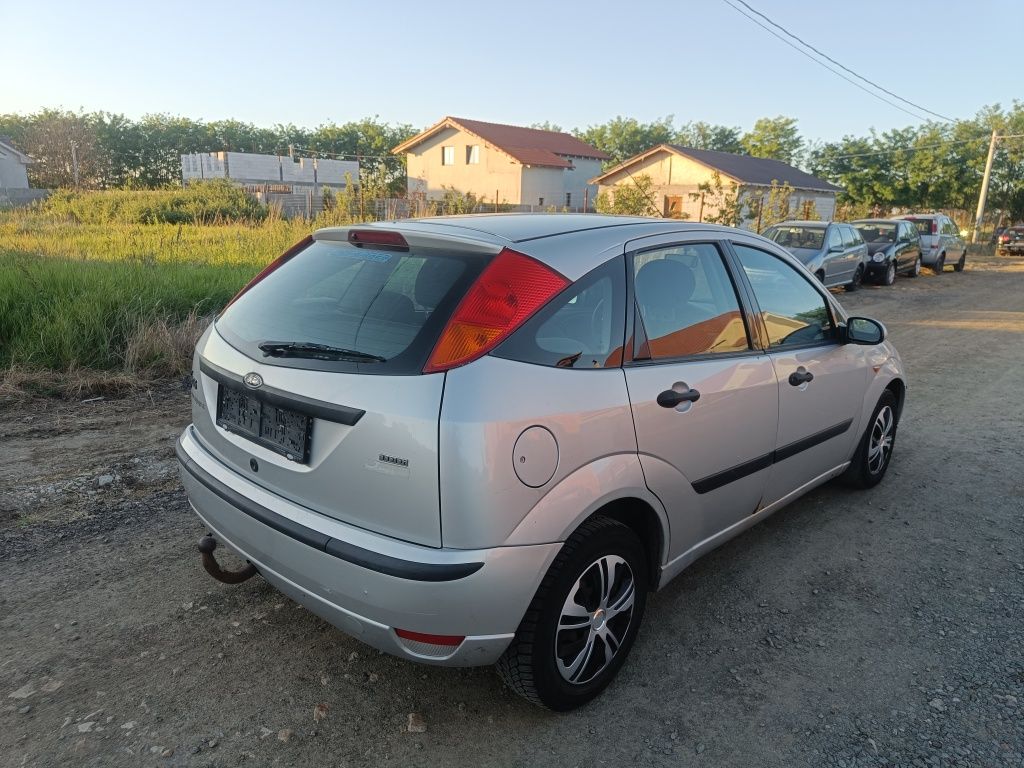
423;248;569;374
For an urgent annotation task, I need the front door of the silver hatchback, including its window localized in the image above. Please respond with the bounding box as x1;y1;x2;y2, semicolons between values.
733;242;867;506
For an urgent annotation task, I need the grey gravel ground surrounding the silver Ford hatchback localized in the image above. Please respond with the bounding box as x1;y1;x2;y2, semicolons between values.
0;249;1024;768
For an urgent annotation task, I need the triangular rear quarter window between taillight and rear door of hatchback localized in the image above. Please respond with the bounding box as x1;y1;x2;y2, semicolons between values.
492;257;626;369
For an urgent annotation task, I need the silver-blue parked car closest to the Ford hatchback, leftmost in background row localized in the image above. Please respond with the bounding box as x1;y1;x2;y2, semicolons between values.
764;221;869;291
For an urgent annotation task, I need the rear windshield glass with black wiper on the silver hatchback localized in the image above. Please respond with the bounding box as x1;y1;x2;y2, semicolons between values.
216;241;489;375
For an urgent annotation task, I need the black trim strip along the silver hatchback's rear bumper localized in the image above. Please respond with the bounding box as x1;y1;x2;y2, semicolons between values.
174;440;483;582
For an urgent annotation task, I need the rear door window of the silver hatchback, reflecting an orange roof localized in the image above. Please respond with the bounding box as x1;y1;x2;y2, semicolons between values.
633;243;750;359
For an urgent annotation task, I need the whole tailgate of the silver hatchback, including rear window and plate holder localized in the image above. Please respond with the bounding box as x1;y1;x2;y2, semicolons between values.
193;228;500;547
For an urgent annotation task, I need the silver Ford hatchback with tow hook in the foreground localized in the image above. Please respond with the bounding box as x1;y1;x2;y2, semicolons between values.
177;214;905;710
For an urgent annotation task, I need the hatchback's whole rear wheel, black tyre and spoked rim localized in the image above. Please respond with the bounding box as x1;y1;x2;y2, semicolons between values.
497;515;650;712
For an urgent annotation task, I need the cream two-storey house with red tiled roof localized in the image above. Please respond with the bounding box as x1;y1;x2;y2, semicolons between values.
392;117;608;210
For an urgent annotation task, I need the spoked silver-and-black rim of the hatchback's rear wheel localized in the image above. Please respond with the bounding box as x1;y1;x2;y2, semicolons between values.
555;555;636;685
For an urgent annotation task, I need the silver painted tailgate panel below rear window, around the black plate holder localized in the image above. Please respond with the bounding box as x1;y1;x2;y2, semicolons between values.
193;329;444;547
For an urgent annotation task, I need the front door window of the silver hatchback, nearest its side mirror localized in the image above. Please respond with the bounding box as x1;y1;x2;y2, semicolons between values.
733;244;836;347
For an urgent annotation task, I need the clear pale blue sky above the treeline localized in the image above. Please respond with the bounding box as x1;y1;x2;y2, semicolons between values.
0;0;1024;140
